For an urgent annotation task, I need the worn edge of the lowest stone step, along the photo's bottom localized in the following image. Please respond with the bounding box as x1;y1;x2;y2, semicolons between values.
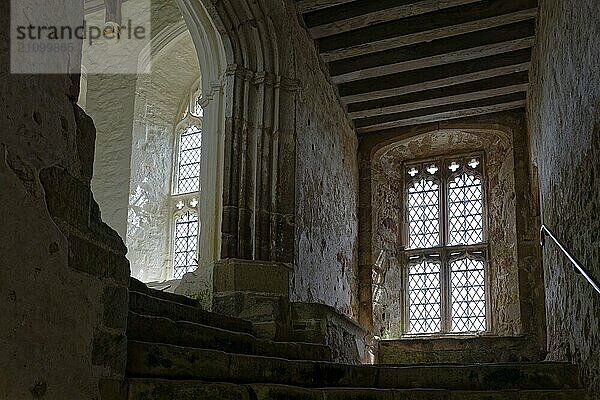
128;378;586;400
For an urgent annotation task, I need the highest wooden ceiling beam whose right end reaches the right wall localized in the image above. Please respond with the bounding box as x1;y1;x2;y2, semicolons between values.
317;0;537;62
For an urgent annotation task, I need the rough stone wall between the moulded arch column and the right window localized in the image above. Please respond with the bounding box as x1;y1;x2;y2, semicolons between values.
287;4;358;318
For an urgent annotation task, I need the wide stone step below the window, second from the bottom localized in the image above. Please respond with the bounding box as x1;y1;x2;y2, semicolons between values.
127;341;581;390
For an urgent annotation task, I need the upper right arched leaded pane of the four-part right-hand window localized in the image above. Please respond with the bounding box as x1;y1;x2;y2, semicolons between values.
448;172;483;245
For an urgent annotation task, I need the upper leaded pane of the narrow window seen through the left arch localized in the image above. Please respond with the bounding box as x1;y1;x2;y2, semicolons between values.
175;125;202;193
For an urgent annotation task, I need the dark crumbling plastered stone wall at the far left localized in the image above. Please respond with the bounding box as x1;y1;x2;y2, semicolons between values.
0;0;129;400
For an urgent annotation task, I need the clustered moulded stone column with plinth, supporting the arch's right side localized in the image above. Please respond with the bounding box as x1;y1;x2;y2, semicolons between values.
213;65;296;339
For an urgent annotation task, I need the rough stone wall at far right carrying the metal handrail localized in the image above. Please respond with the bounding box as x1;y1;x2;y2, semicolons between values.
528;0;600;394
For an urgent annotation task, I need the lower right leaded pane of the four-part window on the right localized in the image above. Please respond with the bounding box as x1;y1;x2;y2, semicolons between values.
450;257;486;332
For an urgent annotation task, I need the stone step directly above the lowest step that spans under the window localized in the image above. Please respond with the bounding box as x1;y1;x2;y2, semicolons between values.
127;312;331;361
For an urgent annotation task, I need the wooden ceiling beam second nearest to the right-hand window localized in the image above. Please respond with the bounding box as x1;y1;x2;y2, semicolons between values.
348;71;529;119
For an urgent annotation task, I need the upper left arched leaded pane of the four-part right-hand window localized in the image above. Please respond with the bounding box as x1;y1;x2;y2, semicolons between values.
407;177;440;249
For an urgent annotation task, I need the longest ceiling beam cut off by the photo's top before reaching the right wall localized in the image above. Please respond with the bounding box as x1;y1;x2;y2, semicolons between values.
305;0;480;39
